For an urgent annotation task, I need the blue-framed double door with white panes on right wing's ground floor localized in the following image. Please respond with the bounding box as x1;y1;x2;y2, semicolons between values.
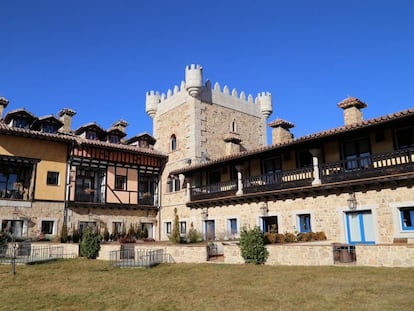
346;211;375;244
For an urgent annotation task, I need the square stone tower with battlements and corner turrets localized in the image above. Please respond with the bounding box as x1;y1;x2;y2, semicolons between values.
146;65;272;239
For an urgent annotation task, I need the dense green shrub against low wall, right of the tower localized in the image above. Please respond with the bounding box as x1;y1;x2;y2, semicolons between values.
240;226;269;265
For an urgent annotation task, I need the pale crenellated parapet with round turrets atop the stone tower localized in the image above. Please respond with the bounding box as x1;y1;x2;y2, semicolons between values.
146;64;273;119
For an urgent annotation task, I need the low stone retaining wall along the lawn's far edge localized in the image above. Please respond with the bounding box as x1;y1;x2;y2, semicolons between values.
32;241;414;267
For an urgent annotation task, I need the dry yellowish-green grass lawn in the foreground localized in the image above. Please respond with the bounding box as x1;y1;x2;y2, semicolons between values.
0;258;414;311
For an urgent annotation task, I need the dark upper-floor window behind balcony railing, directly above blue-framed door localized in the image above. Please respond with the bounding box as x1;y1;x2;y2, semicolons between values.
343;138;371;170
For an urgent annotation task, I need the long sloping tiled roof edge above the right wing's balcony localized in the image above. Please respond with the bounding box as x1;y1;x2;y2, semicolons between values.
170;108;414;175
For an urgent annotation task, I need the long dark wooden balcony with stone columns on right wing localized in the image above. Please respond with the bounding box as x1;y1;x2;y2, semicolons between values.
190;148;414;203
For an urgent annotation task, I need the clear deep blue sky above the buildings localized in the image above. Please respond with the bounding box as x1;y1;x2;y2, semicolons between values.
0;0;414;143
